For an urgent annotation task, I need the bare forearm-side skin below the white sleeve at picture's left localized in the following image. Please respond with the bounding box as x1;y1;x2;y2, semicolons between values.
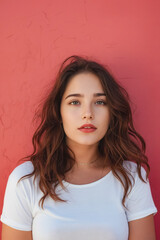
1;223;32;240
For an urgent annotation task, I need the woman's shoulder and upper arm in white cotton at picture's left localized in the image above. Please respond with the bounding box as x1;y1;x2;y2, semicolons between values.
1;161;36;231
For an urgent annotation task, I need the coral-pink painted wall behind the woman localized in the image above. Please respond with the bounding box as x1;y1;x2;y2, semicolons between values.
0;0;160;236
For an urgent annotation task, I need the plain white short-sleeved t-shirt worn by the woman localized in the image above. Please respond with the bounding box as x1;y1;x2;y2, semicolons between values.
1;161;157;240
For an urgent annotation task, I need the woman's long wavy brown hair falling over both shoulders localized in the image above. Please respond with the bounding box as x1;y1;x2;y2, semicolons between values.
19;55;150;208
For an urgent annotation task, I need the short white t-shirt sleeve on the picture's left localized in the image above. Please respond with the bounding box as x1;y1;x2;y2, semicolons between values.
1;165;32;231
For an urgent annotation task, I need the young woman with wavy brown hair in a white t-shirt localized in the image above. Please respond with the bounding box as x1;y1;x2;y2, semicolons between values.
1;56;157;240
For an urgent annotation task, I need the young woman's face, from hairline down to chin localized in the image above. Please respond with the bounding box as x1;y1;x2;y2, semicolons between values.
60;73;110;146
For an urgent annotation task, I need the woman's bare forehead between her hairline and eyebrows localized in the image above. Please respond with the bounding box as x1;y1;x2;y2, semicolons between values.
65;72;103;93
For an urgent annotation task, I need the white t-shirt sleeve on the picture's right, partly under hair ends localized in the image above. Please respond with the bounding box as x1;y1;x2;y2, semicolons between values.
126;167;157;222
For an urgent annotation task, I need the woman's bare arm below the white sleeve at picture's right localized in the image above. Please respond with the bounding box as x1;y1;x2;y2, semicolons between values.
128;214;156;240
